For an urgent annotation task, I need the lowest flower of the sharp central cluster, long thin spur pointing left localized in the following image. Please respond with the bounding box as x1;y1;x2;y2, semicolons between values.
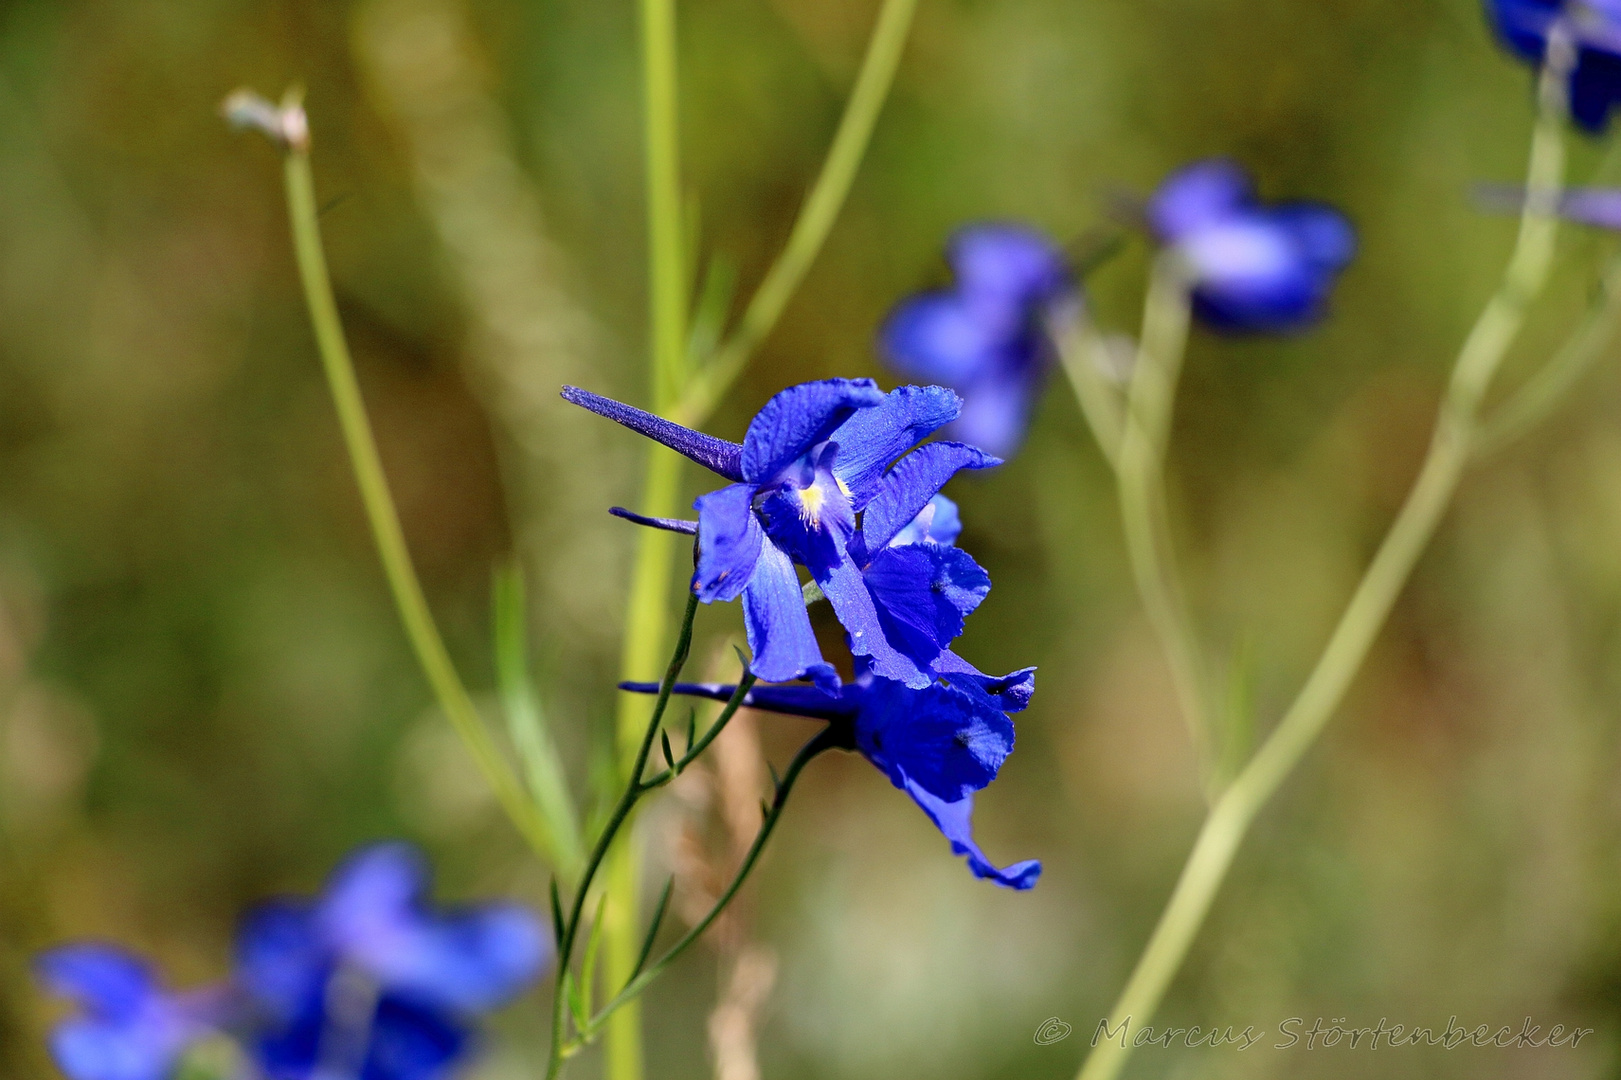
621;642;1041;889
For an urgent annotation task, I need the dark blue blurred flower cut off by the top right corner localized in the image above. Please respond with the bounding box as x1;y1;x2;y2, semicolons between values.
1486;0;1621;133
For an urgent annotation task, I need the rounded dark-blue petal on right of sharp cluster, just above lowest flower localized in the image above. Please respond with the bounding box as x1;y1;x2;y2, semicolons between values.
862;543;990;670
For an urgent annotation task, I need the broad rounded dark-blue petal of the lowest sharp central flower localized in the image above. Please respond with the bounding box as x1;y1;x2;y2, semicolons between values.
856;678;1013;801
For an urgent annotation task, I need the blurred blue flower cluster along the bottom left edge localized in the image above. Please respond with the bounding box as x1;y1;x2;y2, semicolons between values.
36;843;551;1080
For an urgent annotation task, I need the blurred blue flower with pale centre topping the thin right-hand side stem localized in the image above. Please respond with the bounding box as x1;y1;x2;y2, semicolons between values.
1148;159;1357;331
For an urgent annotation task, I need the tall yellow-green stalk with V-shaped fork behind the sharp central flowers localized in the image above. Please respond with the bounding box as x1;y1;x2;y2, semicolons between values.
606;0;916;1080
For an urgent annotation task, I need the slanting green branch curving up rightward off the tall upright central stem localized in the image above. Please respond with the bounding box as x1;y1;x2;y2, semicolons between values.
673;0;917;425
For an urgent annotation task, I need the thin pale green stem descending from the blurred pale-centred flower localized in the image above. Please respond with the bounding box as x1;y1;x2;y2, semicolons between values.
1108;255;1213;774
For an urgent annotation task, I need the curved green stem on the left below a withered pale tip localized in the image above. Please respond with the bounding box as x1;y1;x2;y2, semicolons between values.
284;144;556;864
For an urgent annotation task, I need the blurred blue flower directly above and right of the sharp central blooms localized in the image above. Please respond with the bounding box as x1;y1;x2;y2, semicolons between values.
879;224;1073;456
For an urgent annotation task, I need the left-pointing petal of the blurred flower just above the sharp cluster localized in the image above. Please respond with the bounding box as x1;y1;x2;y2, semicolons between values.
879;292;1020;386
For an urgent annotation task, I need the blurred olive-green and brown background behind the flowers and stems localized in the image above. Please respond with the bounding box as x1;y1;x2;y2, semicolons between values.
0;0;1621;1080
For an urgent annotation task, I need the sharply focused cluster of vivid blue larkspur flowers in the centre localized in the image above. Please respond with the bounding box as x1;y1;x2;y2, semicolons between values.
562;379;1041;889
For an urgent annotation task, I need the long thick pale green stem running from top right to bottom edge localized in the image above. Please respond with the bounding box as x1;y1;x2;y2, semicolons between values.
1080;31;1569;1080
